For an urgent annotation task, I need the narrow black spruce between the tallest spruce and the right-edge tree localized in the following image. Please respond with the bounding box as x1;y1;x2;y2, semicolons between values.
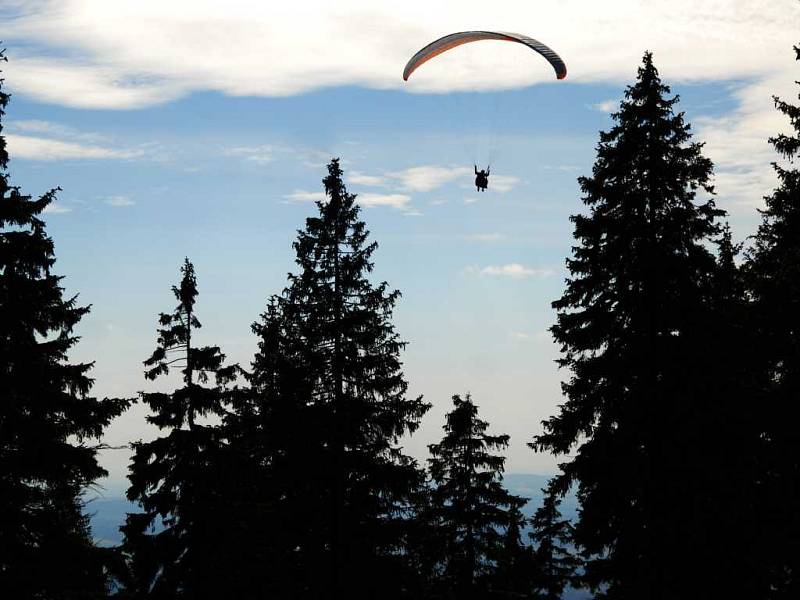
700;224;768;598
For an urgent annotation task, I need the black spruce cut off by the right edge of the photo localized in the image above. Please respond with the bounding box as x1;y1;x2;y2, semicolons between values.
746;41;800;599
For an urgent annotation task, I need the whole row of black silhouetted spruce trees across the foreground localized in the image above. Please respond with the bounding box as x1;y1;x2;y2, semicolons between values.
0;42;800;600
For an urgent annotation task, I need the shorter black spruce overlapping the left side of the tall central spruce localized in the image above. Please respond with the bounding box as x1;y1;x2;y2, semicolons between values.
220;295;330;598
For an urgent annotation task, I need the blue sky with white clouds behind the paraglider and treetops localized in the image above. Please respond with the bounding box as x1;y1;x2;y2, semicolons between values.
0;0;800;494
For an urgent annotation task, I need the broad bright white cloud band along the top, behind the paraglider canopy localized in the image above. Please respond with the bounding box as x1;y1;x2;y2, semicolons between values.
4;0;800;109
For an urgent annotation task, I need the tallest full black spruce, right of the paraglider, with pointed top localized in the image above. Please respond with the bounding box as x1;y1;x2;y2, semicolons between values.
534;53;750;600
